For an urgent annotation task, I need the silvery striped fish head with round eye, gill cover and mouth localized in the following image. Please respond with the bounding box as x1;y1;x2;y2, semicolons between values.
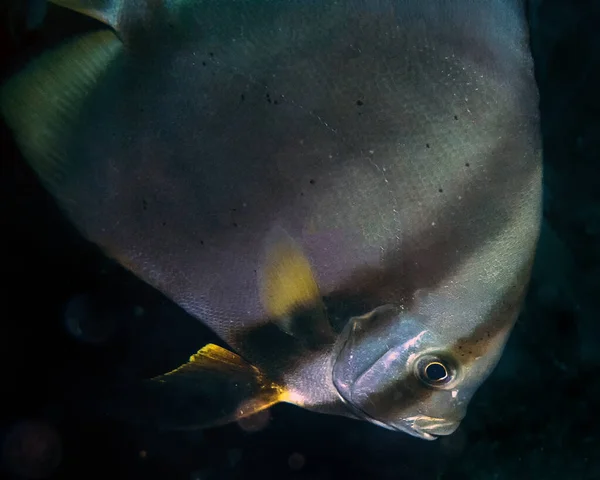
332;298;514;440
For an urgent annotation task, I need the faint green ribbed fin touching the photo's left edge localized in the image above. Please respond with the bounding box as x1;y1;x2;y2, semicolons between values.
0;30;122;190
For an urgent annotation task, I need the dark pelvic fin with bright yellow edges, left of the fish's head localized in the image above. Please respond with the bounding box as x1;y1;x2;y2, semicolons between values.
116;344;287;430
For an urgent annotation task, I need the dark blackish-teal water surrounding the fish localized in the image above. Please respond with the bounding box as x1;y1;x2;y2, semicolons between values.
0;0;600;480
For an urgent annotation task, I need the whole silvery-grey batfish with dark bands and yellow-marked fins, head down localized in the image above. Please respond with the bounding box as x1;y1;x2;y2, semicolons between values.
1;0;542;440
